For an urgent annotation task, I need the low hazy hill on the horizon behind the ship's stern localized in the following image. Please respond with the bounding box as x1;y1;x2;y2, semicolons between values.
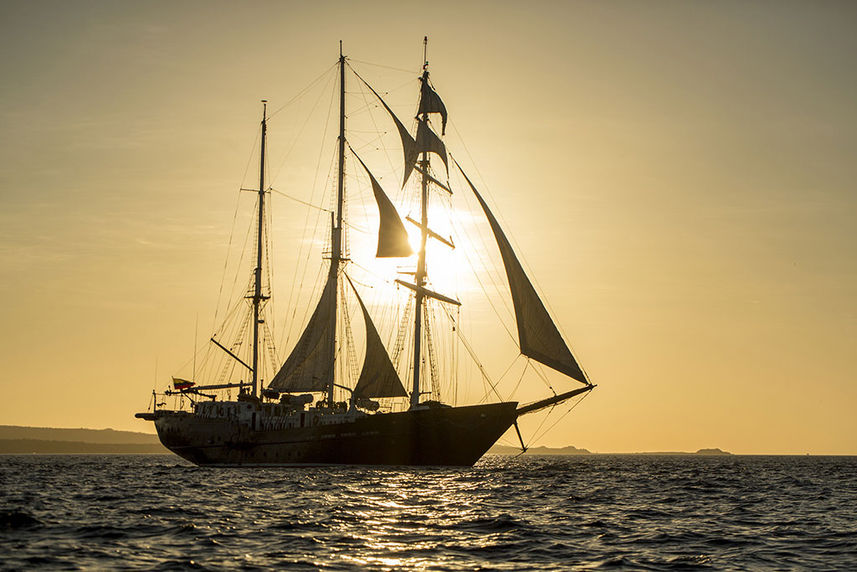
0;425;169;455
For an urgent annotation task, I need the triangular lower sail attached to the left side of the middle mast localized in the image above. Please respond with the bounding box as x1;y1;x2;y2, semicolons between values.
269;274;336;392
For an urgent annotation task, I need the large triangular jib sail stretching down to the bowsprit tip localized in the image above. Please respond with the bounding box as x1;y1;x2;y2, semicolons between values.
456;162;589;384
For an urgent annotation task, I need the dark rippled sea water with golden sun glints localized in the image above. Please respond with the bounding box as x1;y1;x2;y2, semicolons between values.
0;455;857;570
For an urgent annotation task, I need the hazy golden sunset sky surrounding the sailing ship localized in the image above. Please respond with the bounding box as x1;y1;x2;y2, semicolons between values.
0;0;857;454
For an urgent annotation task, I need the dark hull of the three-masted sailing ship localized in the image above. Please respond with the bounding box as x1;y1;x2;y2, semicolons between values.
138;402;517;466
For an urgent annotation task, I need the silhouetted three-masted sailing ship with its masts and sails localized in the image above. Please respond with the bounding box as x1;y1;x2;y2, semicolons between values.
136;39;595;466
